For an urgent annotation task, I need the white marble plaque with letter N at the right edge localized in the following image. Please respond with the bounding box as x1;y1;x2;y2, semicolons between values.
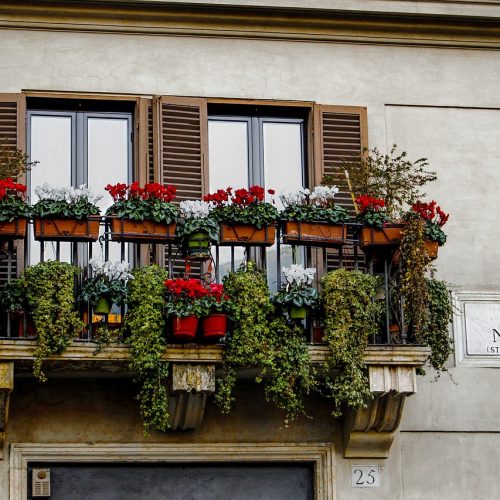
455;293;500;366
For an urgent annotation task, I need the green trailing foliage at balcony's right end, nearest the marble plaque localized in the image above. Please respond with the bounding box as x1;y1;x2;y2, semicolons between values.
420;279;453;376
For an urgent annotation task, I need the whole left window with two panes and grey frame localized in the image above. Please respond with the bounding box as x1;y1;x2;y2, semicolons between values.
28;103;133;264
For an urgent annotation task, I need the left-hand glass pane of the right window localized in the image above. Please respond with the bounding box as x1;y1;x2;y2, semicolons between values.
208;120;249;277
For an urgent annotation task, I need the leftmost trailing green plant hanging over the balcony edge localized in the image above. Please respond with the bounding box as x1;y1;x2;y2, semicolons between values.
19;261;84;381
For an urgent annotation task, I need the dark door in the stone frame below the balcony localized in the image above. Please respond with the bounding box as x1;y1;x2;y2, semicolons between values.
28;464;314;500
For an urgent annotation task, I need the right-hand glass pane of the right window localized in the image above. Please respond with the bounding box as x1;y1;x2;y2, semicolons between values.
262;122;305;290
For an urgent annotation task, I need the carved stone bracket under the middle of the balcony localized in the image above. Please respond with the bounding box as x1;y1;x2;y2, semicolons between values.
169;363;215;430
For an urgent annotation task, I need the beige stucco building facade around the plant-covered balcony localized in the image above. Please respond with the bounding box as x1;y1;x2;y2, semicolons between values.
0;0;500;500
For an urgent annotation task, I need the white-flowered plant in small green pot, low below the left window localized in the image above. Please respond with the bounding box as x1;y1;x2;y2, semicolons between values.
79;259;134;314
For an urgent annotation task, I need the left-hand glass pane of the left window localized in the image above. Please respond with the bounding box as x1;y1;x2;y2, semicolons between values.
30;115;73;264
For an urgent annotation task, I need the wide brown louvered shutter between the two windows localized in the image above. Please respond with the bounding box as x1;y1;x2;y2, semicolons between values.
157;96;208;277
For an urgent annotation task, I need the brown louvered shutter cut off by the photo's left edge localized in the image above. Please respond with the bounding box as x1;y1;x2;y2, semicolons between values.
0;94;26;285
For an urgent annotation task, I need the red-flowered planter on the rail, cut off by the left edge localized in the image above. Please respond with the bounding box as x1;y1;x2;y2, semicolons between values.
0;177;30;239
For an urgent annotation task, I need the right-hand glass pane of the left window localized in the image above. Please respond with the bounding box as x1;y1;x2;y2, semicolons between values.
87;117;130;261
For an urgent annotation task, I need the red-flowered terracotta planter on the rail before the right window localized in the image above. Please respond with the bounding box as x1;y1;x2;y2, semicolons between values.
203;186;278;246
